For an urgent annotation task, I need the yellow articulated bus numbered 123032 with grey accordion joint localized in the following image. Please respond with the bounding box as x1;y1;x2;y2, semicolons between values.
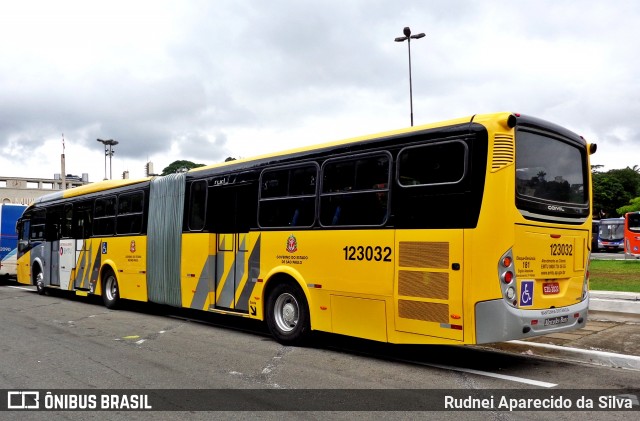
13;113;596;344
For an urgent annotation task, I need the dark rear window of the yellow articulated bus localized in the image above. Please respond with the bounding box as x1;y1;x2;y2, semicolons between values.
516;130;588;205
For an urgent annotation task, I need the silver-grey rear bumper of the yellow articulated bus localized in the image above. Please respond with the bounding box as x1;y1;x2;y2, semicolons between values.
476;297;589;344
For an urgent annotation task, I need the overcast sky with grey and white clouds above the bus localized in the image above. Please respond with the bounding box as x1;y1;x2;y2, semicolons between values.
0;0;640;181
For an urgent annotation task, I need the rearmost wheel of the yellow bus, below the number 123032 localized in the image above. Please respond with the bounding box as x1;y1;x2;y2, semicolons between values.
266;282;310;345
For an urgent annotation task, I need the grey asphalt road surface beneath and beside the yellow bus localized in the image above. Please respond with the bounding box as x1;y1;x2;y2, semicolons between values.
0;283;640;420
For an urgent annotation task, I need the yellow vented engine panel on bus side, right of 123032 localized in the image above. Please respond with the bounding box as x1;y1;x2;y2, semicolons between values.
394;229;465;341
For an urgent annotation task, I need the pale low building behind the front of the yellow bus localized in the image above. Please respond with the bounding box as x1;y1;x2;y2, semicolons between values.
0;173;89;205
